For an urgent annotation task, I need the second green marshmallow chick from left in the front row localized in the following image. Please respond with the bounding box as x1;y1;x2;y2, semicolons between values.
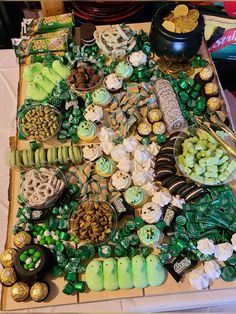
103;257;119;291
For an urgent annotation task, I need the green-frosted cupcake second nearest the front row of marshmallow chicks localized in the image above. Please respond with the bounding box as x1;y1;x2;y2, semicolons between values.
124;186;147;208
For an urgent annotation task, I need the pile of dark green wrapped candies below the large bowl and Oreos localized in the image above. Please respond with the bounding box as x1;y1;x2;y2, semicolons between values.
160;186;236;263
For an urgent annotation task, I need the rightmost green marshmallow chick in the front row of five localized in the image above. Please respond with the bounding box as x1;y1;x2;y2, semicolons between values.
146;254;165;287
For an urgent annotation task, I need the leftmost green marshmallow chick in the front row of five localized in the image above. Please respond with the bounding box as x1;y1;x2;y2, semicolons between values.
85;260;104;291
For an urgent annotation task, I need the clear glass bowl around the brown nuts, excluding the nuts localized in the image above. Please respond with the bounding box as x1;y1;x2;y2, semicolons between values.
69;200;118;245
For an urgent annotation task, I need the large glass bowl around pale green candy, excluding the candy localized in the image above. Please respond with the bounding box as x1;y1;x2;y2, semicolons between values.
174;124;236;186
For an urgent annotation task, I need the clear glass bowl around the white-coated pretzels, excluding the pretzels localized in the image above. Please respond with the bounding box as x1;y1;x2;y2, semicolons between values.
19;166;67;209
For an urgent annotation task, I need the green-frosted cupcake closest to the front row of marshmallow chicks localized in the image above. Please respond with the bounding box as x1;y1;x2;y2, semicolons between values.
138;225;163;247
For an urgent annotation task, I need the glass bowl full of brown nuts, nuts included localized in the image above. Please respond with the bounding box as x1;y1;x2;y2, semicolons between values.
69;200;117;245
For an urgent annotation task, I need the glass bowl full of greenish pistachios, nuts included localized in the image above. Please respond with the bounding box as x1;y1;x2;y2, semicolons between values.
18;104;62;142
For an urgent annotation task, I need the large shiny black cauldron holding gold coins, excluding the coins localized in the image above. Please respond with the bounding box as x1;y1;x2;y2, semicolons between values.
149;4;205;61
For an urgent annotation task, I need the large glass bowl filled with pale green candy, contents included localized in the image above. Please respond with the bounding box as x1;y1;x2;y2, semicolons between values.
174;125;236;186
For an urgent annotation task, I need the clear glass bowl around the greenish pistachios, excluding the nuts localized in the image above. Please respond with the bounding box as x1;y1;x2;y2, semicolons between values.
17;104;62;142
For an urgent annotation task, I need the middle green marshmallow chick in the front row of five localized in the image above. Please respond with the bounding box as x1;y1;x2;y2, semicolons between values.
117;257;134;289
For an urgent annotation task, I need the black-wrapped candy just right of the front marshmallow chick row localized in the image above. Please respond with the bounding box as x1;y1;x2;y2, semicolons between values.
165;253;197;282
